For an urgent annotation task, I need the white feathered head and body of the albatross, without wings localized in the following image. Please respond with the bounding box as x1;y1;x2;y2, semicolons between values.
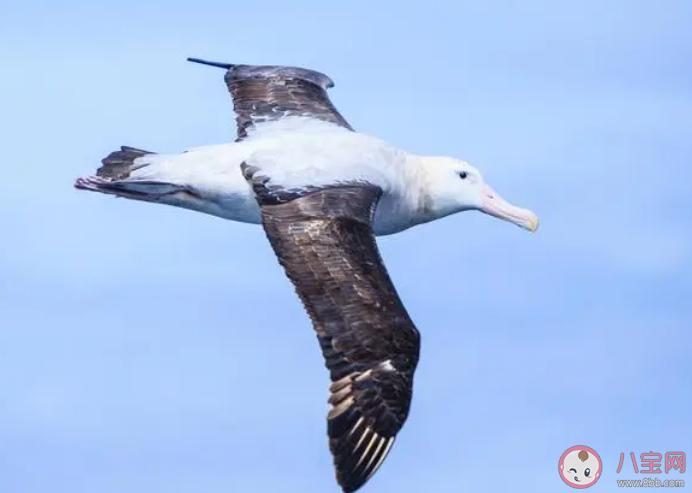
77;117;532;236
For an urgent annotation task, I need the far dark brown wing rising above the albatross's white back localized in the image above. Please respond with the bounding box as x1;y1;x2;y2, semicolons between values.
225;65;353;140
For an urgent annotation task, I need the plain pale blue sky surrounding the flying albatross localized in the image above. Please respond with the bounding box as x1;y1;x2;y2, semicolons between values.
0;0;692;493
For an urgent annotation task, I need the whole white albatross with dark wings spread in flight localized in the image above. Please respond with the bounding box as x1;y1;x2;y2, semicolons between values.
75;58;538;493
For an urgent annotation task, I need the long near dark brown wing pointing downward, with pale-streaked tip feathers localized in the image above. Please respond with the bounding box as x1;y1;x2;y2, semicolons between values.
258;185;420;492
